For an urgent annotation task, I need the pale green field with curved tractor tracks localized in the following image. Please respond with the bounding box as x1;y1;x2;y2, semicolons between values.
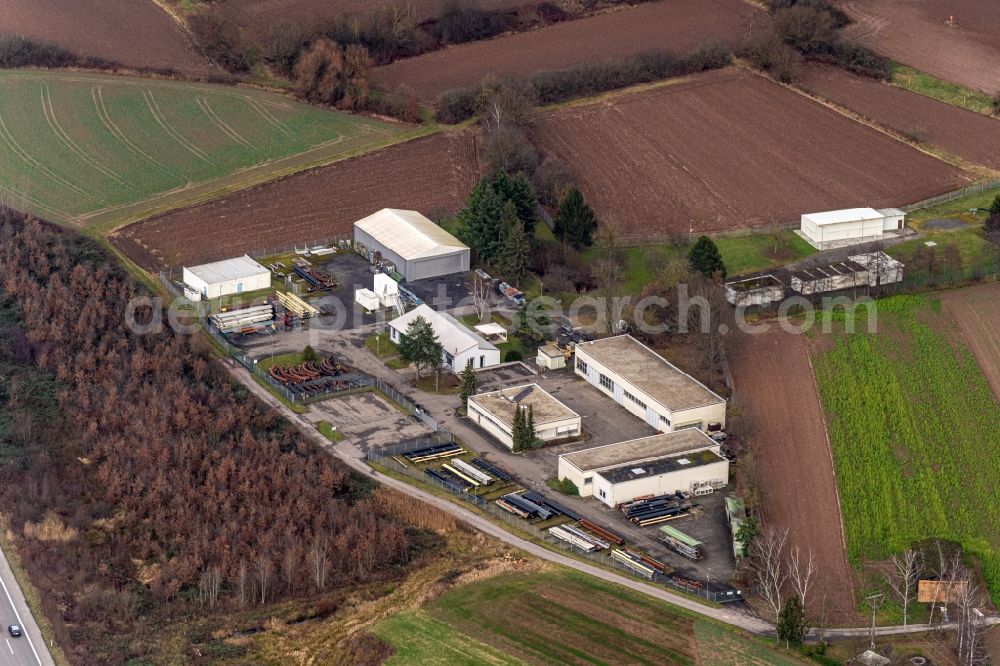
0;70;413;227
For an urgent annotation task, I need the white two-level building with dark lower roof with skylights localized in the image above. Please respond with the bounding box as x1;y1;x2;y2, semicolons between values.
558;428;729;507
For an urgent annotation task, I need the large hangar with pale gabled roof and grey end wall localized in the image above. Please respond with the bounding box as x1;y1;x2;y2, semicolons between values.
354;208;470;282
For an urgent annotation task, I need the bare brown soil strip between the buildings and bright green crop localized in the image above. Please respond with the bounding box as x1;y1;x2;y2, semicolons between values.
731;322;857;624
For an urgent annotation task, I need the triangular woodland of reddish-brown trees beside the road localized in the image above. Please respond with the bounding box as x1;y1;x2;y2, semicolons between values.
0;210;429;663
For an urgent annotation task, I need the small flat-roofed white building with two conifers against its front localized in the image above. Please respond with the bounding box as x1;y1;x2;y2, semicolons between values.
468;384;580;450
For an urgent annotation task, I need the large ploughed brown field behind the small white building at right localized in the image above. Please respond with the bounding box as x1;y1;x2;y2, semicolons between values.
533;69;969;238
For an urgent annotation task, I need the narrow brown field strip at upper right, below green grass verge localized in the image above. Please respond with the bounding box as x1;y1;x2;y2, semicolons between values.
801;63;1000;169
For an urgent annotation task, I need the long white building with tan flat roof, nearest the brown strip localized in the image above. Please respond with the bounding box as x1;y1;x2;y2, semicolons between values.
575;335;726;432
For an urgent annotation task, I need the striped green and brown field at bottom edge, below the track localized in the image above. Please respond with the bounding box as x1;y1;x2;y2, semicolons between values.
374;569;803;666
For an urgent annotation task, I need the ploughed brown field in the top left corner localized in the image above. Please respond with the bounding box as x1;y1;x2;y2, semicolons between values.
0;0;213;74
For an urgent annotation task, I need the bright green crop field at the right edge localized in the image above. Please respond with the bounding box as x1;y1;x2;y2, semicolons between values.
816;296;1000;602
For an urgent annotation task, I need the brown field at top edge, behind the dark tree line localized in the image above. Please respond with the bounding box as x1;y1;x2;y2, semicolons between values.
219;0;530;39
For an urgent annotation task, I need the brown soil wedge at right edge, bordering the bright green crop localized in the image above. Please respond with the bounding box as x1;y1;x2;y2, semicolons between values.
941;284;1000;400
